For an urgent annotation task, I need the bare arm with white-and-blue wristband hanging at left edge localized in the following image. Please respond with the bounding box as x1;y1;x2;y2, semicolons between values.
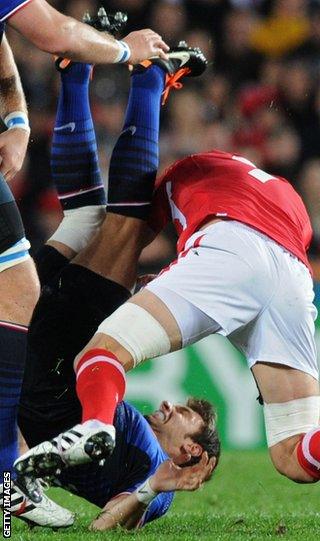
0;36;30;181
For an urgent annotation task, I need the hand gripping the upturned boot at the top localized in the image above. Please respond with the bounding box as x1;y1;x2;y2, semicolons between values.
122;28;170;64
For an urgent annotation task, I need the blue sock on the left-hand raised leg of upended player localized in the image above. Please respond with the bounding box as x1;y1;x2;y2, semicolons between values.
51;63;106;210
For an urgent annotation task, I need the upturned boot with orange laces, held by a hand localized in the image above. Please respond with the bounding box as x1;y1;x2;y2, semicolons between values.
132;41;208;105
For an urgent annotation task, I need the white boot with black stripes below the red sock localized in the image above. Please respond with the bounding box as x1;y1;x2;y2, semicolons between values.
14;423;115;478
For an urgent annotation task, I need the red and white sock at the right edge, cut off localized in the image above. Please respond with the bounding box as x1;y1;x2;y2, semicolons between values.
297;427;320;479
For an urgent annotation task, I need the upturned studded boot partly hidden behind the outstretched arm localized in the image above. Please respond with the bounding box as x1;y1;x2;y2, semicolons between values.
55;7;128;71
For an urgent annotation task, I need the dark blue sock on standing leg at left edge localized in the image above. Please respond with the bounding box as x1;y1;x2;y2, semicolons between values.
0;321;27;477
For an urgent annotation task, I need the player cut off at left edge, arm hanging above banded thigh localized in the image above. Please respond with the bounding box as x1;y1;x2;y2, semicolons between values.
0;22;39;486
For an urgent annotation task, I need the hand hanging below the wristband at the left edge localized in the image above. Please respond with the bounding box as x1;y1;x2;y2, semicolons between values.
0;128;30;182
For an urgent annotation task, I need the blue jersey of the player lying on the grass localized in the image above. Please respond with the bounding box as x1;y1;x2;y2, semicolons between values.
57;402;174;525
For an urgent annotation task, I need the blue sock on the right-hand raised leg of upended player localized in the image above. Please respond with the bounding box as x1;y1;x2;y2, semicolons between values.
107;66;165;220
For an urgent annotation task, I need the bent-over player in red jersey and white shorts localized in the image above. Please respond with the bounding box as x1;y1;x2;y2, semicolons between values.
16;53;320;483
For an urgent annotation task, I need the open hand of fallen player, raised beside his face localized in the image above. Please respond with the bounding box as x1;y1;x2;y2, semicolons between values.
149;452;216;492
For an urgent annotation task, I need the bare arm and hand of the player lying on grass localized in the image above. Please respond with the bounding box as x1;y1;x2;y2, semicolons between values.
91;452;216;530
